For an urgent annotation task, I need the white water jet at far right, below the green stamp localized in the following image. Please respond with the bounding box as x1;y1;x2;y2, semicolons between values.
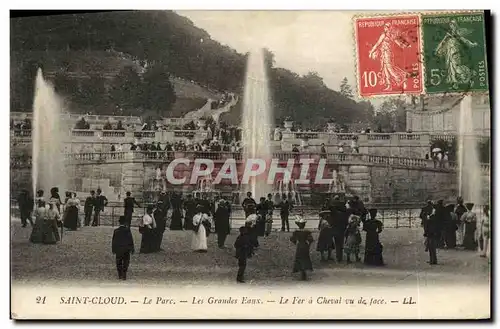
458;96;482;204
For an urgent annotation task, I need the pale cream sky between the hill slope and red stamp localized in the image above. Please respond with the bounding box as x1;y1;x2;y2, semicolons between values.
177;11;359;95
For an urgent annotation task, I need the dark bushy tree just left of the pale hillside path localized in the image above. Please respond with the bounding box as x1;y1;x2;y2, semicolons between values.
142;63;176;116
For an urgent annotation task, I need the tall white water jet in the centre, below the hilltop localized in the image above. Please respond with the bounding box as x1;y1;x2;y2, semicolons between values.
242;49;273;197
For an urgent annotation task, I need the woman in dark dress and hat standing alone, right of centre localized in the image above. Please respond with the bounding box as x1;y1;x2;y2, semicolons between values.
290;216;314;281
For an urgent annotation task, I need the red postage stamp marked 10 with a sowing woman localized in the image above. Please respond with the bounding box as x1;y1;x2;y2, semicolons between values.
354;15;423;97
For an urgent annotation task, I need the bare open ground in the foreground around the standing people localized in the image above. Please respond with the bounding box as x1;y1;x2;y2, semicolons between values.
11;221;489;287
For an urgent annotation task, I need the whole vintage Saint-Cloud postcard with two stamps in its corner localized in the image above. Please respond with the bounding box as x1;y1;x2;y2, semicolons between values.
10;10;492;320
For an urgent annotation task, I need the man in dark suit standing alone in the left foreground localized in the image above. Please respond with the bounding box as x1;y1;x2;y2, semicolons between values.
111;216;134;280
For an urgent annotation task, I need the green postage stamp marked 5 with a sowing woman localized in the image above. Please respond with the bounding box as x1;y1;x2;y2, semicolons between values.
422;13;488;94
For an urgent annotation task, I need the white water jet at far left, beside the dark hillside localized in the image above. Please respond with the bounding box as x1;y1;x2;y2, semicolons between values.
31;69;67;197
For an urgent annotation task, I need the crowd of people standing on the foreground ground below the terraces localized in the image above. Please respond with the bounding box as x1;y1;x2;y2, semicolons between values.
18;184;491;282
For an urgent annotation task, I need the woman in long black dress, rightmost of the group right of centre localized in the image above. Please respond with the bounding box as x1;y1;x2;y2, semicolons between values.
363;209;385;266
